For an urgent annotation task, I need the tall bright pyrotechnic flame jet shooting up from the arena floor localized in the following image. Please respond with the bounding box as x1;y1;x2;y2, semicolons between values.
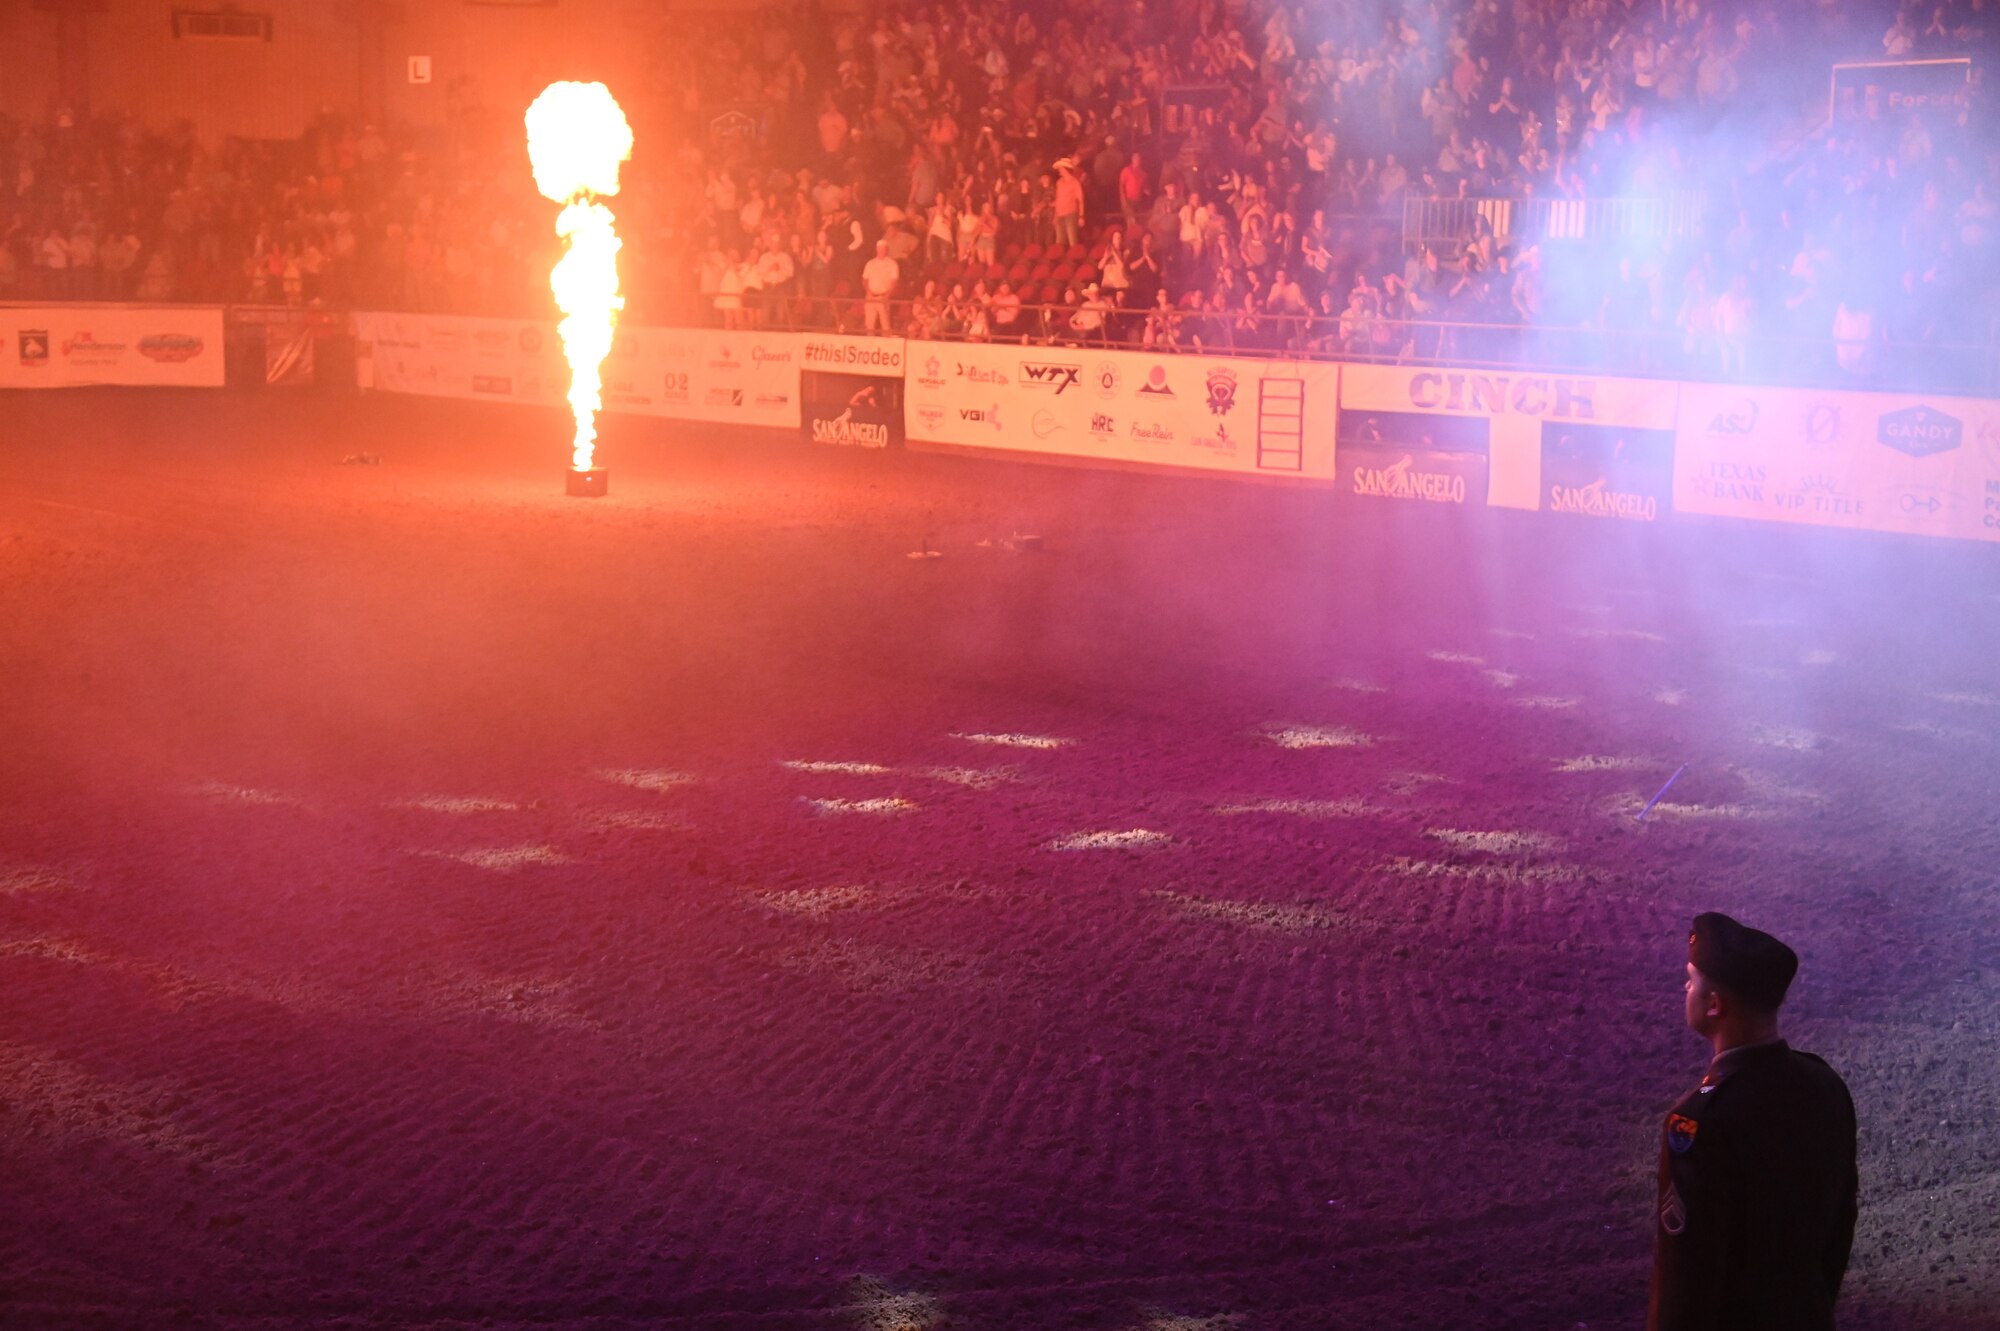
528;82;632;472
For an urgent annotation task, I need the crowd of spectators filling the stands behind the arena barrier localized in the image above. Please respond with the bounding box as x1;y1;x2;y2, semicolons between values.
0;0;2000;376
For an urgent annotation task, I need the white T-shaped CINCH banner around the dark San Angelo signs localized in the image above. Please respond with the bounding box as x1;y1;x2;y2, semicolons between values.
1340;366;1678;508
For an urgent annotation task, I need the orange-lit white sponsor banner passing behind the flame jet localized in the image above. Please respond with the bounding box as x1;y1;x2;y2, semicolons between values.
354;314;800;430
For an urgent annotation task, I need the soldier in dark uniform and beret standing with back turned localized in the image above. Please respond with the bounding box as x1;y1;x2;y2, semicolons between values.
1648;911;1858;1331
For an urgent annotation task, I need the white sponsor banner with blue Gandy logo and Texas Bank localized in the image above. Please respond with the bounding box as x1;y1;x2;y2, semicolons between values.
1674;384;2000;542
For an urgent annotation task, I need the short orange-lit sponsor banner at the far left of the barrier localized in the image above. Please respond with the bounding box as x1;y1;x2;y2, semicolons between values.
0;306;224;388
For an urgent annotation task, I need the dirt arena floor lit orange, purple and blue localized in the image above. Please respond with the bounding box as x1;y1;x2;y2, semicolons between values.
0;392;2000;1331
